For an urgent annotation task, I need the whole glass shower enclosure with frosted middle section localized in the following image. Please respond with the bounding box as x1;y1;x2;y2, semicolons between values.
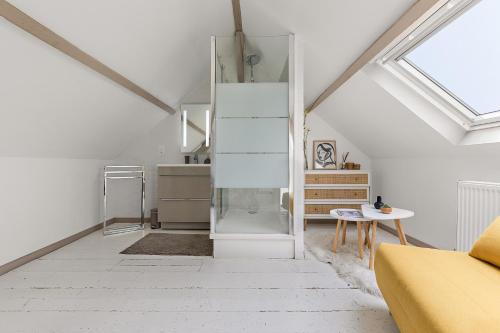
211;36;293;240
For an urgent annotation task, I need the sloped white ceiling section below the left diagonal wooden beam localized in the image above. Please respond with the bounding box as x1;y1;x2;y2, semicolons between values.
0;19;167;159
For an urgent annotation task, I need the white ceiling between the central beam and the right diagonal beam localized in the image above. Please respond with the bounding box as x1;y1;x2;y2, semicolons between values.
241;0;415;106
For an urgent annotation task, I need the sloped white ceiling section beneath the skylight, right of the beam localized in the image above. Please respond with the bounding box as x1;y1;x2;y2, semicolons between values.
314;71;500;158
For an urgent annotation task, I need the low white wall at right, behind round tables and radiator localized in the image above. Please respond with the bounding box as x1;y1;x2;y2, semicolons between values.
372;154;500;249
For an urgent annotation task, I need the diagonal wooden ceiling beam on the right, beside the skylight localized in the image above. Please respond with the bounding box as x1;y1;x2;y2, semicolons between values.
306;0;442;113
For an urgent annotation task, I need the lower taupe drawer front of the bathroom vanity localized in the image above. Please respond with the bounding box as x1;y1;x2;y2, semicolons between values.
158;200;210;222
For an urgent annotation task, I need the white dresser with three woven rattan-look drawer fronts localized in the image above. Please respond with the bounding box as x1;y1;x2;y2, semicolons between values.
304;170;370;227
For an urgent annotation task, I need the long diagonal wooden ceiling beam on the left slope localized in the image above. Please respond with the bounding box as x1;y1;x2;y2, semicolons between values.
0;0;175;114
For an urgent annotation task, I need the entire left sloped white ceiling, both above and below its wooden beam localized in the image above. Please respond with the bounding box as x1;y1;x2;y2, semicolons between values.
0;0;234;159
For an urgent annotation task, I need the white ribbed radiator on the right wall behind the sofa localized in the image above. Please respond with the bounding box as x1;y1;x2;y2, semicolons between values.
457;181;500;251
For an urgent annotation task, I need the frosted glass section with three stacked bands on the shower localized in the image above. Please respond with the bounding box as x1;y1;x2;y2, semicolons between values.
215;82;289;188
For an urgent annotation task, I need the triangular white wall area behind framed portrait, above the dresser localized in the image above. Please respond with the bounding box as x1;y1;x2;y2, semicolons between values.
306;111;371;170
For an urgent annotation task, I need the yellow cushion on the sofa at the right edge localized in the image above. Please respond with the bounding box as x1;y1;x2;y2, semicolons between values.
469;216;500;268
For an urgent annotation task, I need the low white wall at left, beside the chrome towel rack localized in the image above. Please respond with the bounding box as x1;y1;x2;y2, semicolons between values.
0;157;106;265
